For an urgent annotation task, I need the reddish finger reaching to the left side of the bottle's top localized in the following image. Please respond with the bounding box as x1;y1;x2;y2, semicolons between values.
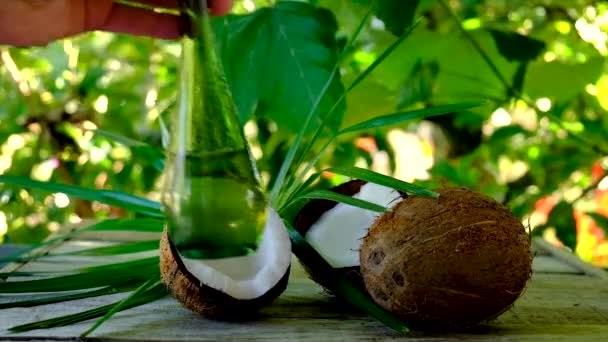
97;4;179;39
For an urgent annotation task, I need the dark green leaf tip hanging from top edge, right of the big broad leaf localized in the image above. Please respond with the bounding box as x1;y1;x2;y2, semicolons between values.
376;0;420;36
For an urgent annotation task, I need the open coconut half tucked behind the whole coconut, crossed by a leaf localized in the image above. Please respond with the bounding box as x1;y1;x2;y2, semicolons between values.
296;180;401;268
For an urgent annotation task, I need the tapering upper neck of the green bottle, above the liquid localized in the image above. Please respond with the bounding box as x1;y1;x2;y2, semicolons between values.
174;0;246;154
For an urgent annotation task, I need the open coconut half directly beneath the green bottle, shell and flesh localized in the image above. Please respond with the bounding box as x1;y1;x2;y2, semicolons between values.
160;210;291;320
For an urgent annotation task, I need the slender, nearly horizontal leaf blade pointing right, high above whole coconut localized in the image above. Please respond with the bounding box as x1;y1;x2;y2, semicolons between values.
339;101;485;134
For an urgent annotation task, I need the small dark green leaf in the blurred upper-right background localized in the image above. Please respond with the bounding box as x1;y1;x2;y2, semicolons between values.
489;29;546;62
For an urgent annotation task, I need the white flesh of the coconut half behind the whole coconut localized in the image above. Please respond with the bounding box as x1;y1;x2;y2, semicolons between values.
304;183;401;268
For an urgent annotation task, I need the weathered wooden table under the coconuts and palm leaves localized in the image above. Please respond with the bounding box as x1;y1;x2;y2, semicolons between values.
0;228;608;341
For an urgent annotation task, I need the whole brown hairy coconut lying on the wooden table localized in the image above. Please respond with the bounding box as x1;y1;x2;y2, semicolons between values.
360;189;532;326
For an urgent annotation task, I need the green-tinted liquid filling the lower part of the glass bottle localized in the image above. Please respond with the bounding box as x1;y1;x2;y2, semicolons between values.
166;150;267;259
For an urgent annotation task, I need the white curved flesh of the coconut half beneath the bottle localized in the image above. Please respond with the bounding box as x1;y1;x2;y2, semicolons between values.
179;208;291;300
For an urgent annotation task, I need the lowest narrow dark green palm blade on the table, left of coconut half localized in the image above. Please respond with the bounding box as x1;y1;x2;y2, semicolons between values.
9;285;167;333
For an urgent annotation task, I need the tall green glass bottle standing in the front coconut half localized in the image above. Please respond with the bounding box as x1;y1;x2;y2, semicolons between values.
161;0;267;259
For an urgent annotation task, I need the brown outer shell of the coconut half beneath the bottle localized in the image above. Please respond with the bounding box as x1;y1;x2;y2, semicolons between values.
160;229;289;321
